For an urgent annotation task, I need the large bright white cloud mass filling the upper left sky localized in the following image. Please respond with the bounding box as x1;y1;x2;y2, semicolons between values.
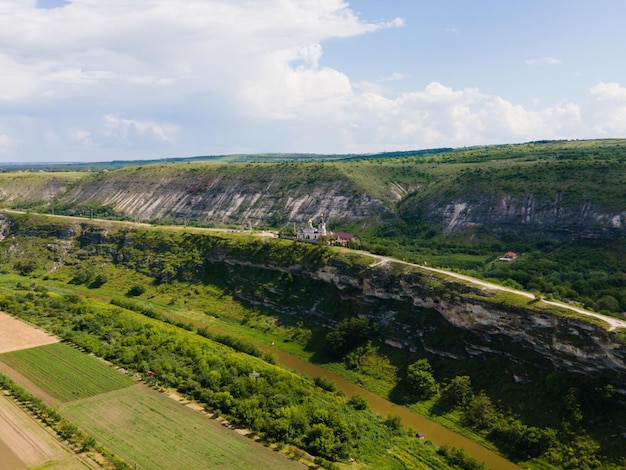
0;0;403;158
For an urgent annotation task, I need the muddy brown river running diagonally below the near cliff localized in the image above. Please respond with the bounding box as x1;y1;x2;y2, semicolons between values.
263;347;520;470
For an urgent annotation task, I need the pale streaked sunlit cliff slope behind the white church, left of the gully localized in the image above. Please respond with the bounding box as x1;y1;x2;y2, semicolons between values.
61;167;392;226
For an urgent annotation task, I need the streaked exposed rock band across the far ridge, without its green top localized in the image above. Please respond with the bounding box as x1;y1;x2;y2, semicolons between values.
0;163;626;240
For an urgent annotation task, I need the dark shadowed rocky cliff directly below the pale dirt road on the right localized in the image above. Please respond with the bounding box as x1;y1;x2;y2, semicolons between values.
205;252;626;377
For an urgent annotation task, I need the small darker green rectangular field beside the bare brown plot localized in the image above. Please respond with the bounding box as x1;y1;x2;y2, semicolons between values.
0;343;135;402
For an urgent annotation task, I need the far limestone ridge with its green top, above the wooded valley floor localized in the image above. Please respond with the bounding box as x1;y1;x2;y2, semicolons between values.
0;141;626;241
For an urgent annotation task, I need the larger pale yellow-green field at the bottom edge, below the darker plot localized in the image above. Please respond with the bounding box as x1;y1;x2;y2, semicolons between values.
59;385;304;470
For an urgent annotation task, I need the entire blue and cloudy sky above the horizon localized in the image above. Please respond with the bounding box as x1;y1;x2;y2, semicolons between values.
0;0;626;162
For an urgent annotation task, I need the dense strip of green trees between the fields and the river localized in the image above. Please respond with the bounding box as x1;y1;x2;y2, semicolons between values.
0;286;458;466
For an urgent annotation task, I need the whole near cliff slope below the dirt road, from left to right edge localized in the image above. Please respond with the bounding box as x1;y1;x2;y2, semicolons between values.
0;215;626;381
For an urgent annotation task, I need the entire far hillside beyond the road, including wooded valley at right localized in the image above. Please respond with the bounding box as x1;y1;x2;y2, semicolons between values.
0;139;626;313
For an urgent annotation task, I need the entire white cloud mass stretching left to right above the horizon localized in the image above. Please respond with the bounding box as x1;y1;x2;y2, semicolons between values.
0;0;626;160
